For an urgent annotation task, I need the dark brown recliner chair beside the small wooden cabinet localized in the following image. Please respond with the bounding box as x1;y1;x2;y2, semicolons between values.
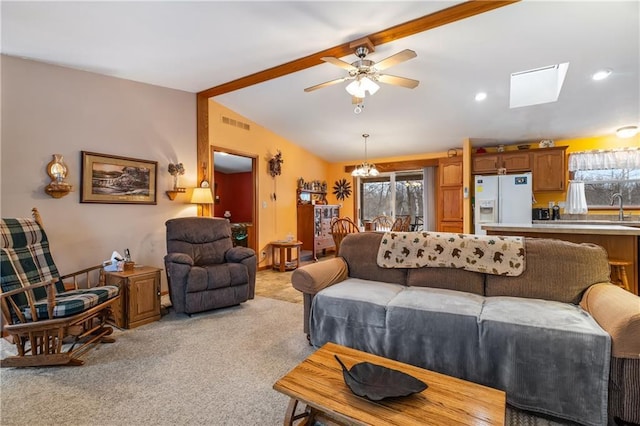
164;217;257;315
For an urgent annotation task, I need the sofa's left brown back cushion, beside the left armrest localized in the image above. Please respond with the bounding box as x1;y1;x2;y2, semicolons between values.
340;232;407;284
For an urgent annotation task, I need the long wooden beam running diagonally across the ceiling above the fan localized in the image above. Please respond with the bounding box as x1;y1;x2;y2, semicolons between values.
198;0;520;98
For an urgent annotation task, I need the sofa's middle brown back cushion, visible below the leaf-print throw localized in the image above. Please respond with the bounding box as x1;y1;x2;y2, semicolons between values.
407;267;484;295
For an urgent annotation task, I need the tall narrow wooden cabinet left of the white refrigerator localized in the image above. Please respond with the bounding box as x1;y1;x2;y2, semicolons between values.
437;157;463;233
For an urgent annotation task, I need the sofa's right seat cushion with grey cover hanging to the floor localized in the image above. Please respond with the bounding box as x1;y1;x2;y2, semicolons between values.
476;297;611;425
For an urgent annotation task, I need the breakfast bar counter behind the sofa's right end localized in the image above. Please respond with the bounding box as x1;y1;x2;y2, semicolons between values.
482;223;640;294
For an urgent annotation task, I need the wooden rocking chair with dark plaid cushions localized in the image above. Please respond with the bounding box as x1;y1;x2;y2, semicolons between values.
0;208;120;367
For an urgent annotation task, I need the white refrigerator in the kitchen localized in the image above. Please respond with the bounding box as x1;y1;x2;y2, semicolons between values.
473;173;532;235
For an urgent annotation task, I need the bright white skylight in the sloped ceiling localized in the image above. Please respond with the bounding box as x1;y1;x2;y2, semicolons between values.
509;62;569;108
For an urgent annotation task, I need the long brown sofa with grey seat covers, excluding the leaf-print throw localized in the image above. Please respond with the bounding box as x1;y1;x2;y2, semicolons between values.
292;232;640;425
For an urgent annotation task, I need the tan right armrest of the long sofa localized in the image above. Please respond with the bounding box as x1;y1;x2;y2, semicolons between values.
580;283;640;359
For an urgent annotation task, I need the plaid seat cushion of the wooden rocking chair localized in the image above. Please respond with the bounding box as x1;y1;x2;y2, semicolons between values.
22;285;119;320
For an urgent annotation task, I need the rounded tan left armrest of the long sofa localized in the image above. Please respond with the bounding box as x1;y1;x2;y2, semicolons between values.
291;257;349;294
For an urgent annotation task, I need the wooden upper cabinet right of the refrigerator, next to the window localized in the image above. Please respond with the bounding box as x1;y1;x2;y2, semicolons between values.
531;146;567;192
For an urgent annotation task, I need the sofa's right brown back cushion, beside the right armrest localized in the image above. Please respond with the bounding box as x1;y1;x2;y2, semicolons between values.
485;238;609;304
